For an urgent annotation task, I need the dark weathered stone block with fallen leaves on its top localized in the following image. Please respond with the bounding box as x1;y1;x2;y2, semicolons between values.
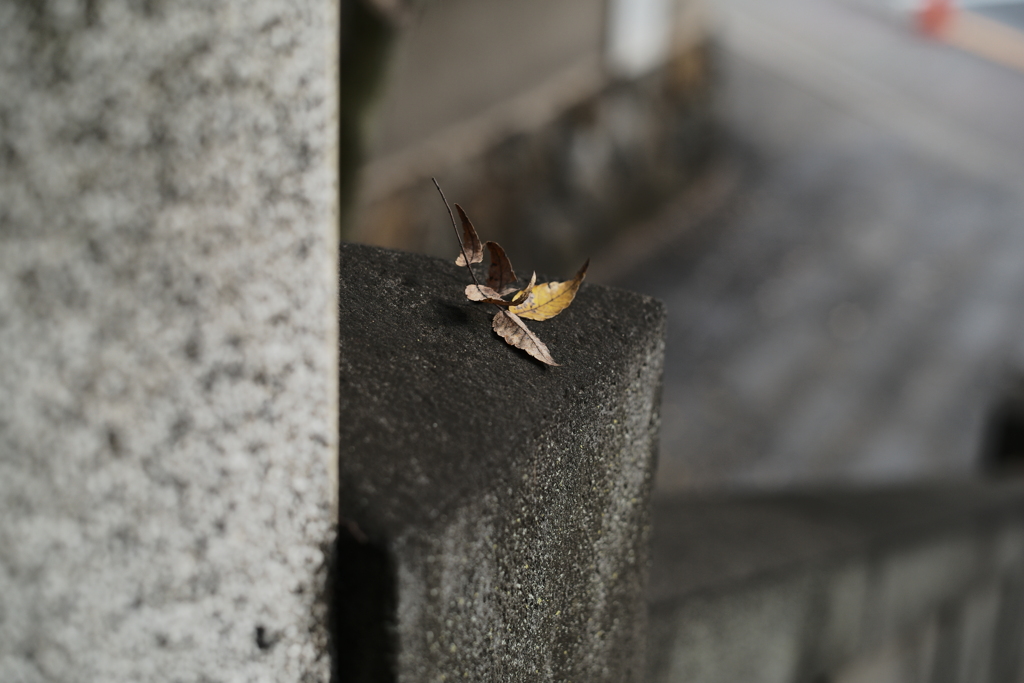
339;242;665;682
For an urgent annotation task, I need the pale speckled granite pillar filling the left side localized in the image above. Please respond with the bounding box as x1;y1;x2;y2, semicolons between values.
0;0;337;683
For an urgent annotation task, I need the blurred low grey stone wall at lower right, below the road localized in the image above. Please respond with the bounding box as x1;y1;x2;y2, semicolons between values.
649;484;1024;683
